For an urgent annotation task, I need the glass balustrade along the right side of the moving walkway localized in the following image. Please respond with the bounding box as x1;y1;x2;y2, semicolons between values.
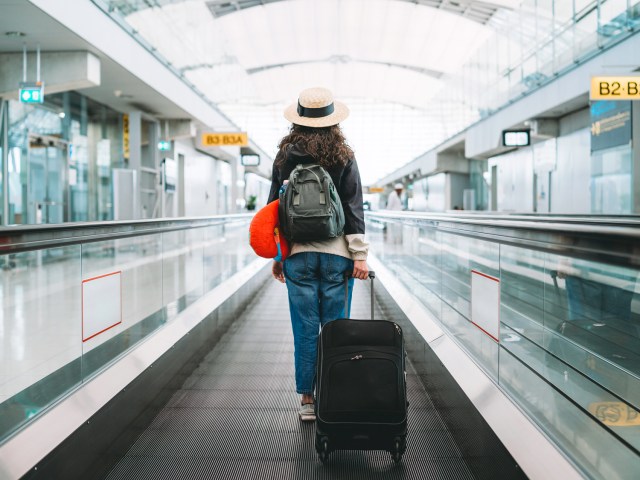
367;213;640;479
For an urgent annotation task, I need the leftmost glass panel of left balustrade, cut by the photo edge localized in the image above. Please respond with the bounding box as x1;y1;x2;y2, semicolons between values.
0;246;82;438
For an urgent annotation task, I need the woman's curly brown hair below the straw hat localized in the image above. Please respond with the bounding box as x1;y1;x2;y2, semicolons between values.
275;123;353;168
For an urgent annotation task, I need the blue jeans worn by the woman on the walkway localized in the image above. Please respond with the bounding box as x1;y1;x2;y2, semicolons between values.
284;252;353;395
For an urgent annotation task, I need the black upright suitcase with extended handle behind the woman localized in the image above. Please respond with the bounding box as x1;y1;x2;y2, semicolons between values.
315;272;407;463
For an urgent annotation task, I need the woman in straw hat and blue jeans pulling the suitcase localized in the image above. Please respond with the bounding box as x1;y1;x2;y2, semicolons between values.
269;88;369;421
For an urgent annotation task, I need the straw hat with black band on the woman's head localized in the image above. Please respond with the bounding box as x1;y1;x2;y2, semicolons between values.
284;87;349;128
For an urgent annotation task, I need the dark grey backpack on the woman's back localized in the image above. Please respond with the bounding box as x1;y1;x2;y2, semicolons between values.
278;163;344;242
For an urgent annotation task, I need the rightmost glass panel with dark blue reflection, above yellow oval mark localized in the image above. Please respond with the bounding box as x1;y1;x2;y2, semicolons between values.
545;255;640;407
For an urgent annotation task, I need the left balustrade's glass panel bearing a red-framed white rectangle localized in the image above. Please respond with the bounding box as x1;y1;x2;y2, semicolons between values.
82;234;166;378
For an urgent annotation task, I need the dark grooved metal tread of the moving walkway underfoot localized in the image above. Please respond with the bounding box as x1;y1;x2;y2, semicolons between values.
107;282;473;480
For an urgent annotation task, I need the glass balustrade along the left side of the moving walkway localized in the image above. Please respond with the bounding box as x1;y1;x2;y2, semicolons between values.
0;216;256;441
